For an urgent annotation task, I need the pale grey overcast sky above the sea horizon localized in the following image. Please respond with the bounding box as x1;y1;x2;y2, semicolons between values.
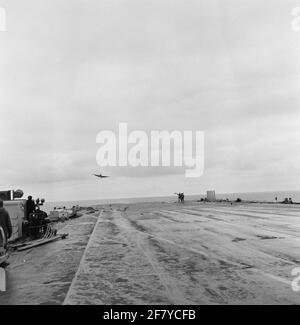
0;0;300;201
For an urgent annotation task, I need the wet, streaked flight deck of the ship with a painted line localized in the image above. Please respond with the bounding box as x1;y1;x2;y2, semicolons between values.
0;203;300;304
